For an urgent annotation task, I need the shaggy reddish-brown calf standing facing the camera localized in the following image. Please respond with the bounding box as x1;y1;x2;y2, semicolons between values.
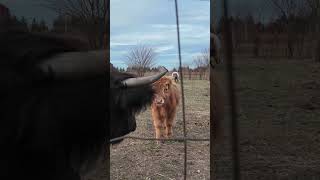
151;76;180;143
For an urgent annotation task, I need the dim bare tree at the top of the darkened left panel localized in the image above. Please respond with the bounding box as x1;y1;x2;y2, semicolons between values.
39;0;109;49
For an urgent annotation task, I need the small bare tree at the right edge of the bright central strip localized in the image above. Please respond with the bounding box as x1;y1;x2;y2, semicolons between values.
193;49;210;79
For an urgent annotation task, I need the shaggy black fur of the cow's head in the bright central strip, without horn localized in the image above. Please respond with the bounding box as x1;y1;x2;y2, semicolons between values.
109;72;154;139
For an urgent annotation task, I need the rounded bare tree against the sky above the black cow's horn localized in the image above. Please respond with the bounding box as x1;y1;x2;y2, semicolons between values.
125;45;157;76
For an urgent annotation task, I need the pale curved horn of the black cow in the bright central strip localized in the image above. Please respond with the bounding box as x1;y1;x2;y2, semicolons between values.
122;66;168;87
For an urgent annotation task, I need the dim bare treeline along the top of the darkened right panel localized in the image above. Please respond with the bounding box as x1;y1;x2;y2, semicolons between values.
218;0;320;62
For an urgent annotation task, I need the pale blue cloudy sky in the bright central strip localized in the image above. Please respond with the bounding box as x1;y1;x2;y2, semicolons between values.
110;0;210;69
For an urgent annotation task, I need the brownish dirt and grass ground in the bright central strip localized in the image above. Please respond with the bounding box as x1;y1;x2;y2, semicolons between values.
110;80;210;180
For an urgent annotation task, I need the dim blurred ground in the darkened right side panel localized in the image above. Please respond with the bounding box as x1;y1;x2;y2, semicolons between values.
214;58;320;180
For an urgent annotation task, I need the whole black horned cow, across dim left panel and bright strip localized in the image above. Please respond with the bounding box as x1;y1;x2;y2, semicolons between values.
0;30;166;180
